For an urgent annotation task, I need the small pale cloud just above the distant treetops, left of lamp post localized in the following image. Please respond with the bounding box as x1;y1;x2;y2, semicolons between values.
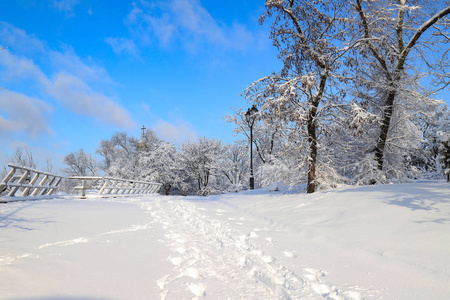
153;120;198;145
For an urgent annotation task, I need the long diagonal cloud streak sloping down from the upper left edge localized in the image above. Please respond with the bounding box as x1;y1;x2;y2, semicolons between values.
0;23;134;129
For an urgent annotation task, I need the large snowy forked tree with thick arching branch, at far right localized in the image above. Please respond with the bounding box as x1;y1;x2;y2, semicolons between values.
349;0;450;178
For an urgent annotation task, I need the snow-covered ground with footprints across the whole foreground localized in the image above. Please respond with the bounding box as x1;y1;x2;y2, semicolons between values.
0;182;450;299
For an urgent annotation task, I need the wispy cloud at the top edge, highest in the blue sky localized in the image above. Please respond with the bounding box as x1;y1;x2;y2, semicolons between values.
110;0;255;53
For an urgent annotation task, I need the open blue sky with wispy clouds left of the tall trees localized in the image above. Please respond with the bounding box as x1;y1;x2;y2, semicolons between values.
0;0;280;169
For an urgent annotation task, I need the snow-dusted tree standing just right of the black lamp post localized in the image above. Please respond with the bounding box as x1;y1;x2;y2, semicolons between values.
245;0;356;193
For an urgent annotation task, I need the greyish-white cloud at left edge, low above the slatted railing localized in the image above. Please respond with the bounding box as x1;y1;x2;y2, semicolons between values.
0;90;53;138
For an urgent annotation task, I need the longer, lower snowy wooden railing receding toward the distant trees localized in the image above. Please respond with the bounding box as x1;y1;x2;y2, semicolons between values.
69;176;162;197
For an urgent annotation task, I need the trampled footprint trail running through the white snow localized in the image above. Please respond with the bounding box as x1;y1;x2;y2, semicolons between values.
142;198;362;300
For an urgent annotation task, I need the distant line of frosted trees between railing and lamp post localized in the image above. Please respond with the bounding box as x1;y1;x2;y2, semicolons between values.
59;129;248;195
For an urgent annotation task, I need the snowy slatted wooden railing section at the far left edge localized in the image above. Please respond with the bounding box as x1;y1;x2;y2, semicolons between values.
0;164;63;197
